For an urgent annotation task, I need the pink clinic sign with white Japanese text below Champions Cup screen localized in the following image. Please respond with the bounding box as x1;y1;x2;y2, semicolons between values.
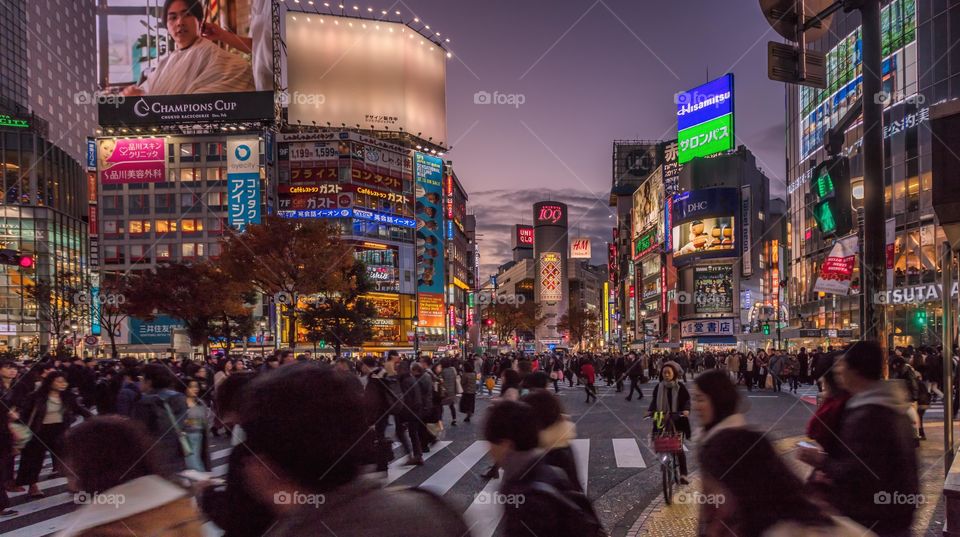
97;138;167;185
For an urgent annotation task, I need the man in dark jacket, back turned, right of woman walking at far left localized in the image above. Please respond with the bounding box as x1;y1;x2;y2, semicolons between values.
133;363;187;474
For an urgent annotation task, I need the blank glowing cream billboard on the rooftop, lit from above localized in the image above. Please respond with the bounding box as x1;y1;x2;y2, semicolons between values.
285;11;449;144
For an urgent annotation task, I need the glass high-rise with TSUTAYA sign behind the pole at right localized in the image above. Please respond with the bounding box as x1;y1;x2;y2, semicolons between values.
786;0;960;348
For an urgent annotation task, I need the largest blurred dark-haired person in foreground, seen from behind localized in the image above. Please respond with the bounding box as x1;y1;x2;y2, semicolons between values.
244;363;469;537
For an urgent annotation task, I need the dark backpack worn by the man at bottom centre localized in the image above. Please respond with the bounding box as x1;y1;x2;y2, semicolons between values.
530;464;607;537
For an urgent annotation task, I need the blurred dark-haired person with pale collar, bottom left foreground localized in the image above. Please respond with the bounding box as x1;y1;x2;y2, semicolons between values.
57;416;203;537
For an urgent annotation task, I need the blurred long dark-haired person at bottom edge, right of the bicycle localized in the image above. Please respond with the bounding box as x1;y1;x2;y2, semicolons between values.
700;428;875;537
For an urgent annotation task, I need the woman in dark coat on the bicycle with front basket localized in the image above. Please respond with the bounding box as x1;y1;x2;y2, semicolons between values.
647;361;690;485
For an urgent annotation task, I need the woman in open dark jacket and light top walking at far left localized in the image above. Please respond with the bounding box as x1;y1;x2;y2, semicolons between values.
17;371;93;498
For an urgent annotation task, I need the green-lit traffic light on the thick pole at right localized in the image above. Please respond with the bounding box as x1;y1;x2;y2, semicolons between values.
810;157;853;237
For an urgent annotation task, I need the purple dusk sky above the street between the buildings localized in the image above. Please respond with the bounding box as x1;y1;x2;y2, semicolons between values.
384;0;785;277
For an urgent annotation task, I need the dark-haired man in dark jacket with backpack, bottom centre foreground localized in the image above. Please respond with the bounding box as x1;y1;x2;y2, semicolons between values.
483;401;601;537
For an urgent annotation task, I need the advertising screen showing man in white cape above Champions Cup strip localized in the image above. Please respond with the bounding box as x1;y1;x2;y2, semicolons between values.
96;0;274;125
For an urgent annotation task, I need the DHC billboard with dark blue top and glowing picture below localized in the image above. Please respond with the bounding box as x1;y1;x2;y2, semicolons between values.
670;188;740;266
